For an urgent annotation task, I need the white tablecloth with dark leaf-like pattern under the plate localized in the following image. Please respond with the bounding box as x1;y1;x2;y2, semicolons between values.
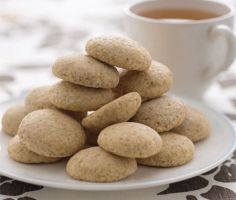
0;0;236;200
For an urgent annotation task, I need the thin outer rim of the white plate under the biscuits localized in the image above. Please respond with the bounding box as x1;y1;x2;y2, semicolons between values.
0;96;236;191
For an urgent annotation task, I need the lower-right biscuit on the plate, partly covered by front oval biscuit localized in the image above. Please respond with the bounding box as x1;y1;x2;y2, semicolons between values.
137;132;195;167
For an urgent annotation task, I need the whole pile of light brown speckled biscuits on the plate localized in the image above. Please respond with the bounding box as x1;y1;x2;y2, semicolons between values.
2;37;210;182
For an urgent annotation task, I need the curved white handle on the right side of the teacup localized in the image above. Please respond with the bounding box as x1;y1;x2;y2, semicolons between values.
205;25;236;78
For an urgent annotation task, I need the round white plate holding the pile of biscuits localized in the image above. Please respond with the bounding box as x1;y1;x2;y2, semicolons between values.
0;99;236;191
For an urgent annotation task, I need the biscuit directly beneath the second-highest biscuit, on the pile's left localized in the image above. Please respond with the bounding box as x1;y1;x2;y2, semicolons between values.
49;81;116;111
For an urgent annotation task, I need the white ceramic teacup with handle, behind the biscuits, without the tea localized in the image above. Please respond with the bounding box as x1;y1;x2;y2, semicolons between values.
125;0;236;98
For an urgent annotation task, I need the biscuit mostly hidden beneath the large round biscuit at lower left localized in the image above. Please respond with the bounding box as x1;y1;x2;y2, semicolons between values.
7;135;61;164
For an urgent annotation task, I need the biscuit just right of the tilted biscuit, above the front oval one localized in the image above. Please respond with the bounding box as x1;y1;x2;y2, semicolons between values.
131;95;186;133
